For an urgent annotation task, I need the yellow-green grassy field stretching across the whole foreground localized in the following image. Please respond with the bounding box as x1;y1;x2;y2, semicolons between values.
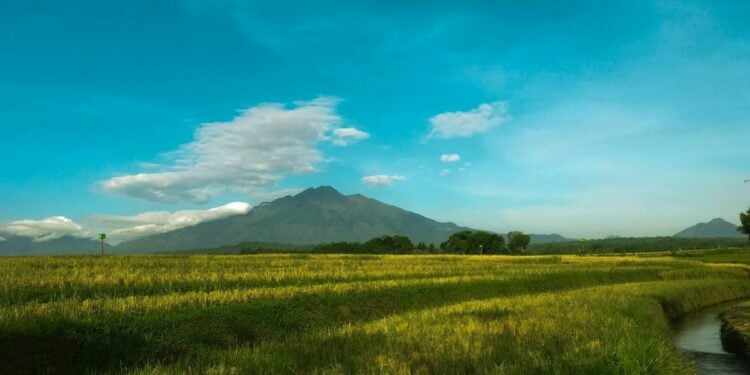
0;251;750;374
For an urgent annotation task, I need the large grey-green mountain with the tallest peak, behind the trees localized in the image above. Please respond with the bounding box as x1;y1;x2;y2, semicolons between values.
117;186;469;252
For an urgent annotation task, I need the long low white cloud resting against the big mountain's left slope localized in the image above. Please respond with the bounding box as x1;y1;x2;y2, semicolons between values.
89;202;251;242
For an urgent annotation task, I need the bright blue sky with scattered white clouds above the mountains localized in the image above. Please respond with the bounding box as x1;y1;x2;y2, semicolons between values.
0;1;750;237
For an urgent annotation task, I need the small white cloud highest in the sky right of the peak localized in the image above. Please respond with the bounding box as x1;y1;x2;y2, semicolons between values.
427;102;510;139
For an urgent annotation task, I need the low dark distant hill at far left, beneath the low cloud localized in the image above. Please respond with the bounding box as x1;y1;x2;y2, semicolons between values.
0;233;111;255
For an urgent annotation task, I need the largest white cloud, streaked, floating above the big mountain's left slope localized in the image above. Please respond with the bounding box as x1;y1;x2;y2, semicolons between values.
100;97;367;203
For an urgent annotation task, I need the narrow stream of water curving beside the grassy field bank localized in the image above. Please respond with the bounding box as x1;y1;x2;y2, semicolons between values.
675;303;750;375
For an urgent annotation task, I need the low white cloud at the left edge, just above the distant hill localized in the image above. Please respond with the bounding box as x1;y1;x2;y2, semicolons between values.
0;216;90;242
